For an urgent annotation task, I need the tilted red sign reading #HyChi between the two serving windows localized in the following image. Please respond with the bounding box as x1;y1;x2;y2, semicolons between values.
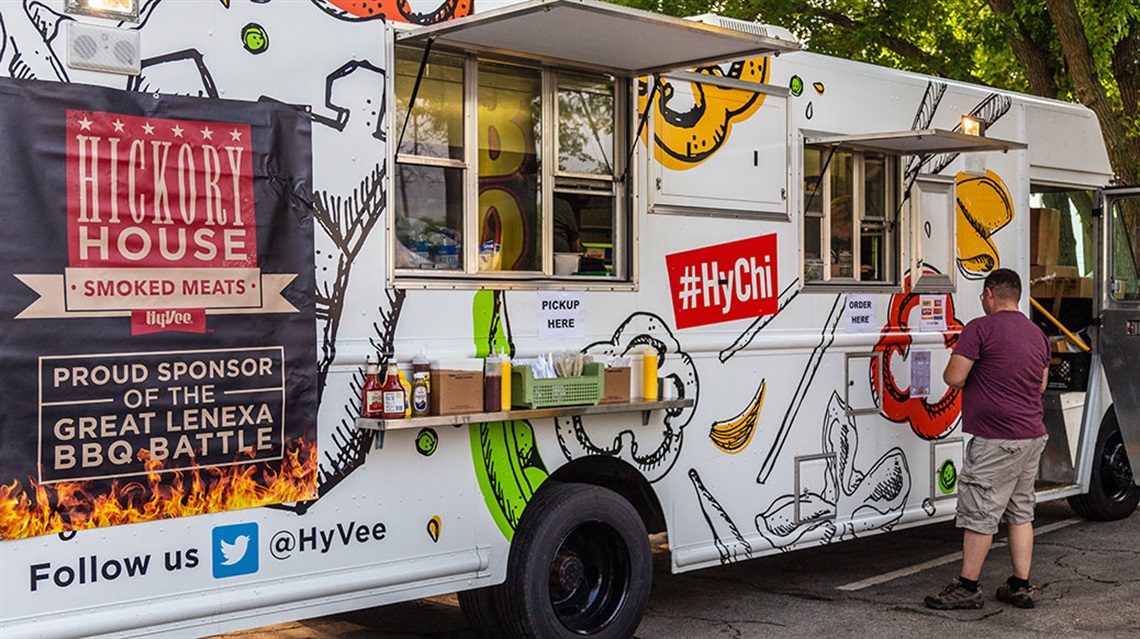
665;234;780;328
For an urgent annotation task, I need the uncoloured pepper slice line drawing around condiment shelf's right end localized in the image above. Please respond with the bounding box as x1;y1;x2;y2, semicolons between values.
554;312;700;482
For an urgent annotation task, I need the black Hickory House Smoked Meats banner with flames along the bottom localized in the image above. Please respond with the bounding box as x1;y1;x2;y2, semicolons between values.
0;79;317;539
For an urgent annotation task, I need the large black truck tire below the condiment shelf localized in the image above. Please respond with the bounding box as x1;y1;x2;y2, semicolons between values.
497;483;653;639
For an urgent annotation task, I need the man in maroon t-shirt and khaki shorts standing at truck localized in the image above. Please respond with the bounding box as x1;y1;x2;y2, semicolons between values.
926;269;1050;611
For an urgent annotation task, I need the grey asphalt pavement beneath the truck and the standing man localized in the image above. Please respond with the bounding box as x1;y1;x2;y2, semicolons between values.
215;502;1140;639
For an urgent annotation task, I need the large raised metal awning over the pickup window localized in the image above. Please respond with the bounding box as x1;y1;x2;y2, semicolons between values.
396;0;800;76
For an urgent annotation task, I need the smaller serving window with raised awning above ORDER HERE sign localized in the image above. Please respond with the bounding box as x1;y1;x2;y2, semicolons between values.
801;129;1026;293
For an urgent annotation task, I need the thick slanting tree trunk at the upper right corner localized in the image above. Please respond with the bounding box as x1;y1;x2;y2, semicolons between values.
1045;0;1138;183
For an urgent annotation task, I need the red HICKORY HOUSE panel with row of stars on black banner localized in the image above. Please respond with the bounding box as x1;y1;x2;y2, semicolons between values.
67;110;258;269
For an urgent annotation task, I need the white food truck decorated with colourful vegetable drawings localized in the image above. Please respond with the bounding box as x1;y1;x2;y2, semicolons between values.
0;0;1140;638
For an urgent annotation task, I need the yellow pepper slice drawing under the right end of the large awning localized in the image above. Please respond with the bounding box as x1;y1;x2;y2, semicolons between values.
637;57;771;171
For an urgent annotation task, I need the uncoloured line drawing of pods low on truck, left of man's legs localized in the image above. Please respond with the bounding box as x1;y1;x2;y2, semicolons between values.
756;391;911;550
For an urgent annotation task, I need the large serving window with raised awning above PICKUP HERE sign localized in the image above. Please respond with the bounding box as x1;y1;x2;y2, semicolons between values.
389;0;798;288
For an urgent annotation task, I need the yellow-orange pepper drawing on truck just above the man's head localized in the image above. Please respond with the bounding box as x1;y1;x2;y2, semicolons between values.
956;171;1013;279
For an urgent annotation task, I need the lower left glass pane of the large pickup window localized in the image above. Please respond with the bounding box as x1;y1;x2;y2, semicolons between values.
393;163;463;271
